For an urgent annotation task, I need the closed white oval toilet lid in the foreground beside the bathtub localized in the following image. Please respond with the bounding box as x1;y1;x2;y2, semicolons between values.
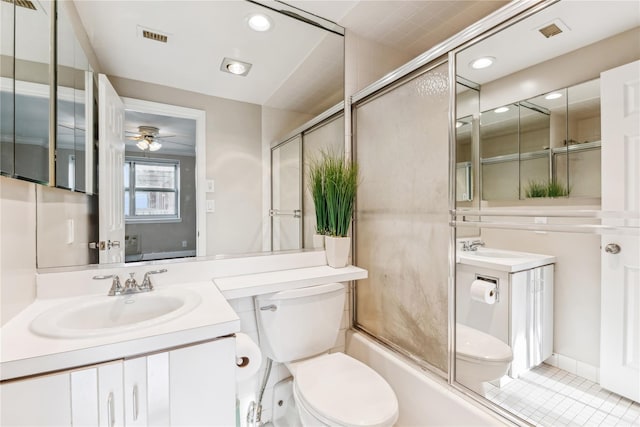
294;353;398;427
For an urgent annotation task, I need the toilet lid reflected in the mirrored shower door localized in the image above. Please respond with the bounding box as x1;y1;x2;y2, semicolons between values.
456;323;513;362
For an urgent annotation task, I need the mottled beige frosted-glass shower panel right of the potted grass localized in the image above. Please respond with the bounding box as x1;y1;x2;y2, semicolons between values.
354;64;449;372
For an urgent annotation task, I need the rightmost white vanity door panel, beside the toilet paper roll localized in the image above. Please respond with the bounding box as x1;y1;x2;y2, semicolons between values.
169;338;236;426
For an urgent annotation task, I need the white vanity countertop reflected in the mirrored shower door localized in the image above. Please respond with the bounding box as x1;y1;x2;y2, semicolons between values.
456;248;556;273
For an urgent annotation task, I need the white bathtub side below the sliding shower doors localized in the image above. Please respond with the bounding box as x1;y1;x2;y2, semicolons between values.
346;331;512;427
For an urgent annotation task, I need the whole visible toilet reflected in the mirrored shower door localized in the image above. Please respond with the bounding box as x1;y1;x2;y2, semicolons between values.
456;323;513;396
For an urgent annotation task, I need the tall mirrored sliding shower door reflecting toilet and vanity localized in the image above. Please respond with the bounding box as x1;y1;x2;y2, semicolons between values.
452;1;640;425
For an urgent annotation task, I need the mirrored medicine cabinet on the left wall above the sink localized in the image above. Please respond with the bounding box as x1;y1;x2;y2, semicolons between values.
0;0;94;193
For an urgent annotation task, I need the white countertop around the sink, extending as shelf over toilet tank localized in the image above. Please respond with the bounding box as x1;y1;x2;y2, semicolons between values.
0;260;367;380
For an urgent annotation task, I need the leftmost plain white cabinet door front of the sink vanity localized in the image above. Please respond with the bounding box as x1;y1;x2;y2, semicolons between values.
0;372;71;427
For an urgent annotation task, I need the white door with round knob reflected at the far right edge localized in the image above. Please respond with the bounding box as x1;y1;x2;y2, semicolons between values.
600;61;640;401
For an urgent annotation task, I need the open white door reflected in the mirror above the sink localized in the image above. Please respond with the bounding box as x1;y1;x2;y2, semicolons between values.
98;74;124;264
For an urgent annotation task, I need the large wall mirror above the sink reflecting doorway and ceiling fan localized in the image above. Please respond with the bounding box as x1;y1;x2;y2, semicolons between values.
35;1;344;268
